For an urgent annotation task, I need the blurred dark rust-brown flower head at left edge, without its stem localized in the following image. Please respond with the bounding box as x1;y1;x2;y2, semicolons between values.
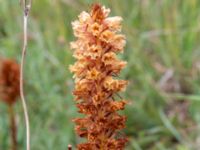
0;59;20;105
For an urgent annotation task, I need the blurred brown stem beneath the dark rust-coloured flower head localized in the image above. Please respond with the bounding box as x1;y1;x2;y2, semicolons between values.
8;104;17;150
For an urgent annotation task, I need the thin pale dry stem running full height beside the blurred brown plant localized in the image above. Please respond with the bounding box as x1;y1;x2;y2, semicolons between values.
20;0;31;150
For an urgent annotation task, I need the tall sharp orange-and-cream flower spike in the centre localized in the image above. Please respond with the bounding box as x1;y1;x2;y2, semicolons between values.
70;4;127;150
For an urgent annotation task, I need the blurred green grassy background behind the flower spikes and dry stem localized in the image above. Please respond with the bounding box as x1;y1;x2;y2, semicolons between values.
0;0;200;150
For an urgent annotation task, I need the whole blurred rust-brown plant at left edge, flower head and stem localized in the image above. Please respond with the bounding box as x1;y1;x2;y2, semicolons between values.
0;59;20;150
